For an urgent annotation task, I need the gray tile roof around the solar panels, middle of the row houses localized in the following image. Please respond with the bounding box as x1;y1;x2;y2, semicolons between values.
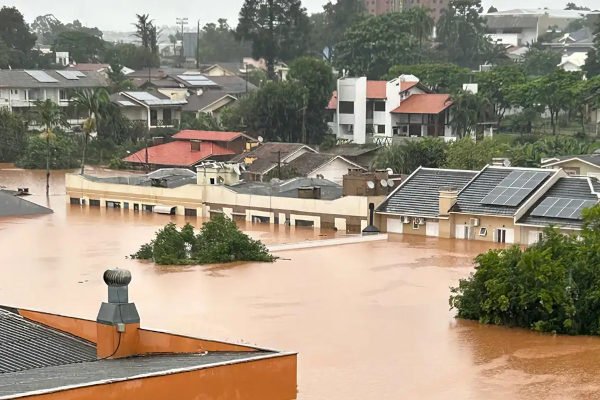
451;167;556;216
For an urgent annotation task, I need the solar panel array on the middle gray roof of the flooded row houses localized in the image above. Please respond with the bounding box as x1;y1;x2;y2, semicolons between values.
481;170;548;207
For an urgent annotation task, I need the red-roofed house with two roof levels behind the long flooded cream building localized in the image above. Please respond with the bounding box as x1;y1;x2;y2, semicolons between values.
123;130;254;169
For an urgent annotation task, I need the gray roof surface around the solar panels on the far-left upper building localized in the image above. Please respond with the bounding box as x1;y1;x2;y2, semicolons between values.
0;69;108;89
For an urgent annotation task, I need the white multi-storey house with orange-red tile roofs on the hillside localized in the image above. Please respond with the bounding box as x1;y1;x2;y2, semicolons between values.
327;75;455;144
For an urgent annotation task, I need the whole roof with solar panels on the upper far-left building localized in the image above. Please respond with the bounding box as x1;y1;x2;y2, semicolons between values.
0;69;108;88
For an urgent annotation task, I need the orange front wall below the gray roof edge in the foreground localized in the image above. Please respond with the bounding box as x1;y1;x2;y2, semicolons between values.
27;354;297;400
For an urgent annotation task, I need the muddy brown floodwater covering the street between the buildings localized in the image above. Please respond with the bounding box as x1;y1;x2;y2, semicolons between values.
0;166;600;400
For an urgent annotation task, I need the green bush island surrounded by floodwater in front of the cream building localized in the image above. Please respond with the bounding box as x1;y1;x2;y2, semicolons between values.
131;215;275;265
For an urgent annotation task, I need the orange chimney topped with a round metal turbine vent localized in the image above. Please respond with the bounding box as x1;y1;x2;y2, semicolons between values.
96;268;140;358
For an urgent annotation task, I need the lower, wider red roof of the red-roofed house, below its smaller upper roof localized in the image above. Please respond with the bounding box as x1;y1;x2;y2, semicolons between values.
123;141;235;167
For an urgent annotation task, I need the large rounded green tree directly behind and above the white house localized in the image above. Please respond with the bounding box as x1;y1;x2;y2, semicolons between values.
334;13;418;79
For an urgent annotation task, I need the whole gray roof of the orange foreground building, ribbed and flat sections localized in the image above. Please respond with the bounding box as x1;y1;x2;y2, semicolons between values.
0;308;275;399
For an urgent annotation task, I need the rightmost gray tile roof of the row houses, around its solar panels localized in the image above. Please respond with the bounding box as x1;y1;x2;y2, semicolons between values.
518;177;599;229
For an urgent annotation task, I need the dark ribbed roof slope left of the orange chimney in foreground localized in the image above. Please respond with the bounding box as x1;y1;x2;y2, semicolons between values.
0;309;96;376
